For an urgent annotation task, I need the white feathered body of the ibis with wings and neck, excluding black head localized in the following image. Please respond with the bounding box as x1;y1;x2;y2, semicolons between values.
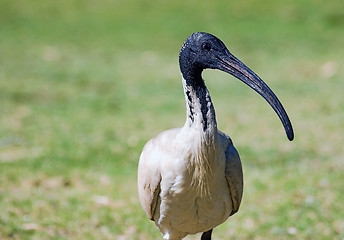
138;76;243;240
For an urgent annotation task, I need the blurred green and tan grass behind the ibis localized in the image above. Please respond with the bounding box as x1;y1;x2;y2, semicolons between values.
0;0;344;240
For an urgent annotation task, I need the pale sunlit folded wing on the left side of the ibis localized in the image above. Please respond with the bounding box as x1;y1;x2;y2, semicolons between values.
137;139;161;220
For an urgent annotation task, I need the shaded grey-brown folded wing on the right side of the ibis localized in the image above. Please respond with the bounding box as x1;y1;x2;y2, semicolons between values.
225;141;244;215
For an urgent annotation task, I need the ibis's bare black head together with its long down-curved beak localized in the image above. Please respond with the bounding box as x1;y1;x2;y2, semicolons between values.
179;32;294;140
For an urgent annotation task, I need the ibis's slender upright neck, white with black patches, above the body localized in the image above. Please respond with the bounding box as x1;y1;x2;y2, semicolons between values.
183;73;217;135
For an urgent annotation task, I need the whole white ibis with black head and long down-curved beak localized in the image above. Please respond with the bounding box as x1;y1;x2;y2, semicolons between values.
137;32;294;240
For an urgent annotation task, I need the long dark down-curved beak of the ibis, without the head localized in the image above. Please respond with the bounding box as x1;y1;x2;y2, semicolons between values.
216;50;294;141
